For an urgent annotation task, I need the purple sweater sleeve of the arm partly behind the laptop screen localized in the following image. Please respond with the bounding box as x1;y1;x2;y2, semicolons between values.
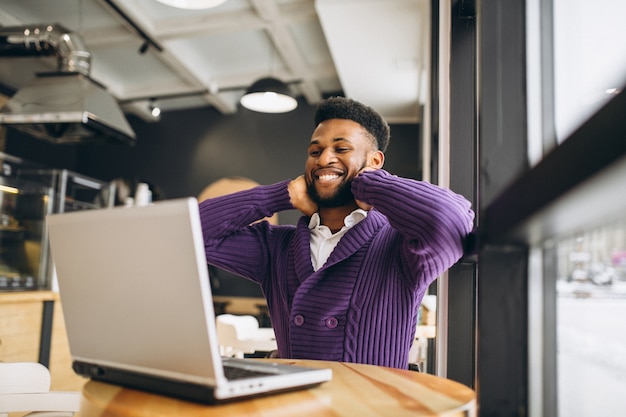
199;180;293;282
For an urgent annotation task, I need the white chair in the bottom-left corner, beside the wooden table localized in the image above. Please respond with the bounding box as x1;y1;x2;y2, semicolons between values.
0;362;80;417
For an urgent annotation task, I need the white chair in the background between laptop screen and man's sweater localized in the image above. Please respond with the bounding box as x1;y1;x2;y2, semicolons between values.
216;314;276;358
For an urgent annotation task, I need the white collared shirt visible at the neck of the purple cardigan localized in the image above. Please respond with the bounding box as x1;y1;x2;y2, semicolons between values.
309;209;367;271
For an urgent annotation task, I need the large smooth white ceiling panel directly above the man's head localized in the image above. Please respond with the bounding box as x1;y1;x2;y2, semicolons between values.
317;0;430;123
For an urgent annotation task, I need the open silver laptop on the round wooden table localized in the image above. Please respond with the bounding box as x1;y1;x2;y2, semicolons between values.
46;198;332;404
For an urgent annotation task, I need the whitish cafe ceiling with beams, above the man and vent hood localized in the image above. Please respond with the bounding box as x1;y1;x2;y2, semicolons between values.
0;0;430;123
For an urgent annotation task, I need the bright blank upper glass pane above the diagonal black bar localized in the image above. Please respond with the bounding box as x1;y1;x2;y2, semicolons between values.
553;0;626;143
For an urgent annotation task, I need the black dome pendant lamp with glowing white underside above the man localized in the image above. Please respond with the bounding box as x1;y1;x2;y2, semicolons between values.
240;77;298;113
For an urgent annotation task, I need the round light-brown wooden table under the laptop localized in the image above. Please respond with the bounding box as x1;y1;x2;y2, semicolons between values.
80;359;476;417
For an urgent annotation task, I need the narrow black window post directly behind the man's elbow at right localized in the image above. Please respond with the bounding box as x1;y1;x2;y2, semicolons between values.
447;0;479;388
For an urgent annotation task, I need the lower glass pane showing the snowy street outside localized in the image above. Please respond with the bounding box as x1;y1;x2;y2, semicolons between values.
557;221;626;417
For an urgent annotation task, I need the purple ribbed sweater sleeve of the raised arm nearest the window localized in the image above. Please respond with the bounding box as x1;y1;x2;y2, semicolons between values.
352;169;474;281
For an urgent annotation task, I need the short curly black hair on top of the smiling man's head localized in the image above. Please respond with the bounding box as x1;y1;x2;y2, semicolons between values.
315;97;390;152
